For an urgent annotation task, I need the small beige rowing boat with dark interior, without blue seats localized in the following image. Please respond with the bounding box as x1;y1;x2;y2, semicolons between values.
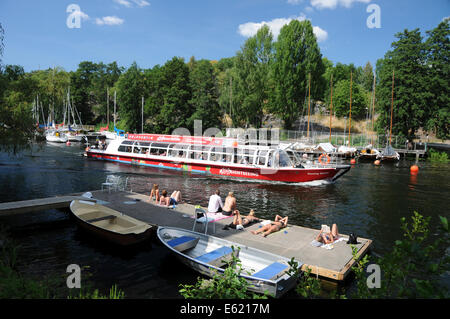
70;200;152;246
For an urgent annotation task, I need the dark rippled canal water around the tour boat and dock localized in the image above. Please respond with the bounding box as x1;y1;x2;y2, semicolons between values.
0;143;450;298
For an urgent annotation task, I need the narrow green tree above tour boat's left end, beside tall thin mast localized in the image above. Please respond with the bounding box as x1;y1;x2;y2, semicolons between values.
117;62;144;132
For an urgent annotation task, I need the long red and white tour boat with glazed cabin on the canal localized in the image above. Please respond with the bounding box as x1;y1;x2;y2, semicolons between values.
85;134;350;183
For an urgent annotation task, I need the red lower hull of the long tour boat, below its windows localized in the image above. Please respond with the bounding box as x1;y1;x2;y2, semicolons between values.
86;151;350;183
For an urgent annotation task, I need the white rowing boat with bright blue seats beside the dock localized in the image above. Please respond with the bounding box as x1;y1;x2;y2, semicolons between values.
157;227;302;298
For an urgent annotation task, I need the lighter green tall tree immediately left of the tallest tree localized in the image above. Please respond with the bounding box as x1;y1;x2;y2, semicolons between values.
232;25;273;127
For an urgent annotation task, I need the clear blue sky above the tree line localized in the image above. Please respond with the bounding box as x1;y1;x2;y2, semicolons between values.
0;0;450;71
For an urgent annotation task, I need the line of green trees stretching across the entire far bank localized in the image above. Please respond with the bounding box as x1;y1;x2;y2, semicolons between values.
0;19;450;148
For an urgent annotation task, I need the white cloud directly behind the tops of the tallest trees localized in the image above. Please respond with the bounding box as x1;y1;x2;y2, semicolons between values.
238;15;328;42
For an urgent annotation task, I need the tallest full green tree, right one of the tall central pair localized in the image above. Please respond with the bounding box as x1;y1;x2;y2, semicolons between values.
271;20;325;129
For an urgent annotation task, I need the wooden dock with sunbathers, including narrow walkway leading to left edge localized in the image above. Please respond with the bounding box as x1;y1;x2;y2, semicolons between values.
0;191;372;281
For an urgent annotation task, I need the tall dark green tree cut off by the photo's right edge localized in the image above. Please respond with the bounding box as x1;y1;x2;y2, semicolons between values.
425;18;450;139
